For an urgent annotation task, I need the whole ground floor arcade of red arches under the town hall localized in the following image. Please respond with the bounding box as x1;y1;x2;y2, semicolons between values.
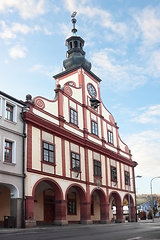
25;178;135;227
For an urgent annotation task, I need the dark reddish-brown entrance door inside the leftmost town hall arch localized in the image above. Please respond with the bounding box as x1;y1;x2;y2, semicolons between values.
44;196;55;223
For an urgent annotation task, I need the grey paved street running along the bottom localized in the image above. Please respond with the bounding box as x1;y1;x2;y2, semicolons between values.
0;222;160;240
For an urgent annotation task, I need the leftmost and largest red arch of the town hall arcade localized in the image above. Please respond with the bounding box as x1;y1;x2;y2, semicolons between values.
26;178;67;225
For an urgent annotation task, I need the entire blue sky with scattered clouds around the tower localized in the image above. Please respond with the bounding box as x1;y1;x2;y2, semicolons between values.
0;0;160;194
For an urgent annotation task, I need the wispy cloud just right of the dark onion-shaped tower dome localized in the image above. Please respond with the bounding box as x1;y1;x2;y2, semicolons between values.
91;49;147;91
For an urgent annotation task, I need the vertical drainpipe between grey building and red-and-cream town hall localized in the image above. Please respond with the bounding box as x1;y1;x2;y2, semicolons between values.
21;105;29;228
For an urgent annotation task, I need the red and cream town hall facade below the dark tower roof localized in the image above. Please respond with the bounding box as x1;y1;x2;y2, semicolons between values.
25;17;136;226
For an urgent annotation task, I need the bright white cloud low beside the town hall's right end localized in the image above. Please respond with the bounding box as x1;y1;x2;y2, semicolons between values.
123;130;160;177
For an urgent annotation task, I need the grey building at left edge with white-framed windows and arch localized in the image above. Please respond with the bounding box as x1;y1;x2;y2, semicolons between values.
0;91;26;227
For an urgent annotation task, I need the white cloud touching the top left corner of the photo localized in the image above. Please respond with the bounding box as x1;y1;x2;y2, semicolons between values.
0;0;48;19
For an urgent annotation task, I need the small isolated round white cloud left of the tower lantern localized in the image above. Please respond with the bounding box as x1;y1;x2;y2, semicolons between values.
9;45;27;59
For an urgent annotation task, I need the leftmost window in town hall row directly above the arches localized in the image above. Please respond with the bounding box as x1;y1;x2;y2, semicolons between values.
43;142;54;163
